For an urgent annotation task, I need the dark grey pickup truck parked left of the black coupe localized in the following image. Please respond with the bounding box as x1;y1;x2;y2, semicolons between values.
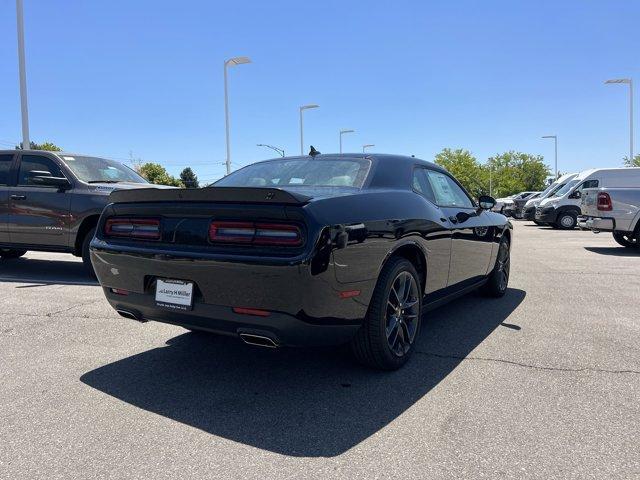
0;150;170;272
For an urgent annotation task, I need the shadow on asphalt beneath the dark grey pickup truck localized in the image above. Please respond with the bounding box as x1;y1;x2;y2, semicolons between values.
0;257;98;288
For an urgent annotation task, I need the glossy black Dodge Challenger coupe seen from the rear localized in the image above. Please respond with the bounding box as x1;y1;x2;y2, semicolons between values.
91;154;512;370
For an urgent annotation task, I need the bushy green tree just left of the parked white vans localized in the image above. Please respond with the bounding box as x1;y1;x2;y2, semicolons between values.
486;150;551;197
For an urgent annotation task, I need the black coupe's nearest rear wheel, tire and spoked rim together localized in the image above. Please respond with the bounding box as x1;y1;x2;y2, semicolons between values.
351;257;423;370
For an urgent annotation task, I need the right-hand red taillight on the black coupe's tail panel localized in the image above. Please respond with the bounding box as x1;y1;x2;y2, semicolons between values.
209;221;302;247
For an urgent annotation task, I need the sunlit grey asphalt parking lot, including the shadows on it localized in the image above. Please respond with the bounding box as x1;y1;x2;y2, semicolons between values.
0;222;640;479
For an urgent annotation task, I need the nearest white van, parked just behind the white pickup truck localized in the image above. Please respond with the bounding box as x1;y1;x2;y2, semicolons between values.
535;168;640;230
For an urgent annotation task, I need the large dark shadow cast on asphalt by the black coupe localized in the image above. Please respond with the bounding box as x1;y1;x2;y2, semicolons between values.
80;288;526;457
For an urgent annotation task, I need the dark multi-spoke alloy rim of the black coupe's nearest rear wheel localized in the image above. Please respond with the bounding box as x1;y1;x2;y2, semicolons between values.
385;272;420;357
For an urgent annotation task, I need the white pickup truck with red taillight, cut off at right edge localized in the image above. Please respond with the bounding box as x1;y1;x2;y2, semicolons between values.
579;186;640;248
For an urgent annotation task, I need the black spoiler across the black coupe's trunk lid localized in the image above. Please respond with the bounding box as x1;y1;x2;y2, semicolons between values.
109;187;312;205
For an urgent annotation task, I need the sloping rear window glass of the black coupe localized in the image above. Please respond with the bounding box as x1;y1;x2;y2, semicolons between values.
214;158;371;188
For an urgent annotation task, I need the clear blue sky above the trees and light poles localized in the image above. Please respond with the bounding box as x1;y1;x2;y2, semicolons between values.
0;0;640;181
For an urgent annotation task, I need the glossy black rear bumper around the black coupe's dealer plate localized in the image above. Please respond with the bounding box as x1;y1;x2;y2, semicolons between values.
91;247;375;346
